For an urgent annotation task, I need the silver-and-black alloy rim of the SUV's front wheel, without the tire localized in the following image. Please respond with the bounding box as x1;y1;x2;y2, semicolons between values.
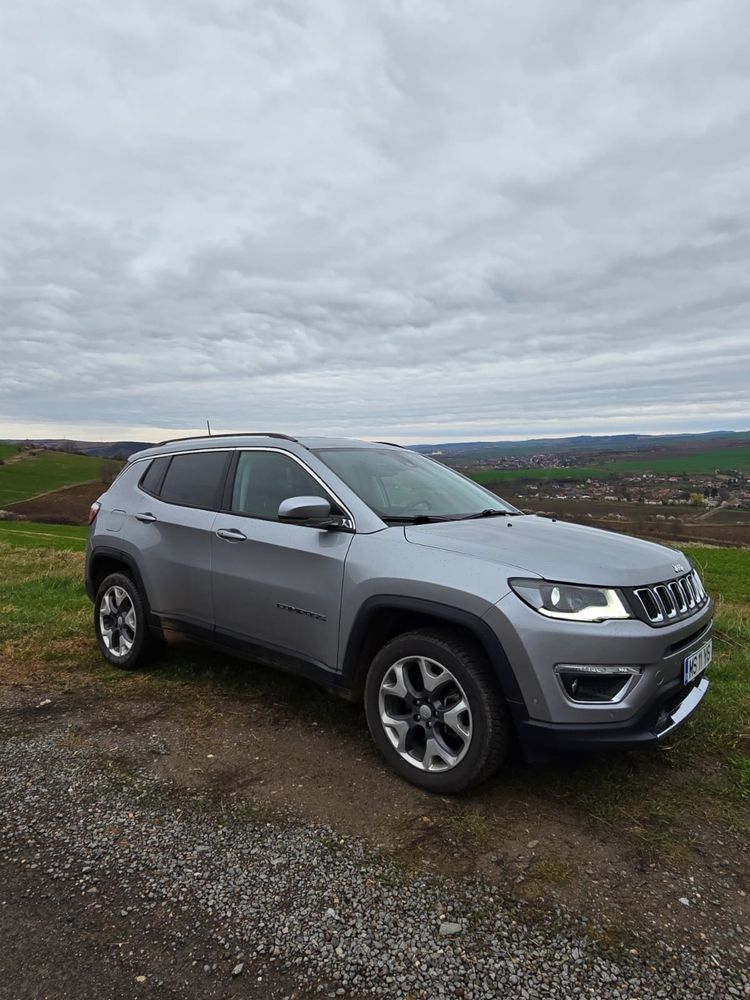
378;656;472;772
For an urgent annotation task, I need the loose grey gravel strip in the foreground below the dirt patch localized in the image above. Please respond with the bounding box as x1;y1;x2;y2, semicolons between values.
0;734;750;1000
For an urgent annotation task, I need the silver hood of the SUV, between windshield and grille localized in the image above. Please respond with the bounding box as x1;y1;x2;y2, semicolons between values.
405;515;690;587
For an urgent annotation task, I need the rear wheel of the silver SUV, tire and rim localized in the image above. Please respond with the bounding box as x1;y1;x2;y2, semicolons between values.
94;573;164;670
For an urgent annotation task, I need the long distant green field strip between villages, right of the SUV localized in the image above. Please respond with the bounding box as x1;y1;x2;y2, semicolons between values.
470;448;750;486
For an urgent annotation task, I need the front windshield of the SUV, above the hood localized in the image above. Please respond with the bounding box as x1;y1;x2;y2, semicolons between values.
316;448;518;521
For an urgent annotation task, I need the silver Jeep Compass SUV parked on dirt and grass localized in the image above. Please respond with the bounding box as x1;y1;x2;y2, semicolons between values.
86;434;713;793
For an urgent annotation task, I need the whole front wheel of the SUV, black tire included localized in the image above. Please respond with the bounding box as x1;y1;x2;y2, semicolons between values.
365;628;513;795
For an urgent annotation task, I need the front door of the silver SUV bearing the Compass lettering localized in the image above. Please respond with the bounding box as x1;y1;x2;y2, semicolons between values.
211;448;353;668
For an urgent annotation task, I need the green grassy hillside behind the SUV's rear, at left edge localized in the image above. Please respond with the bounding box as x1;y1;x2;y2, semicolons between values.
0;451;120;508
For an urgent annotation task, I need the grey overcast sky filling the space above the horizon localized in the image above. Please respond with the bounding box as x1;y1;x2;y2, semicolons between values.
0;0;750;441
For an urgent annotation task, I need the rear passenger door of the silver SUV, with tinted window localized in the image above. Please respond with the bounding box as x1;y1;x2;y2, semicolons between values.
127;451;232;629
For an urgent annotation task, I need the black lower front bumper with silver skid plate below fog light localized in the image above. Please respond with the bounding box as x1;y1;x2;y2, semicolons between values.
518;677;710;757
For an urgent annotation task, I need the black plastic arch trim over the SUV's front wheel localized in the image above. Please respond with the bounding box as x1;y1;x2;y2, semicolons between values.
342;594;529;723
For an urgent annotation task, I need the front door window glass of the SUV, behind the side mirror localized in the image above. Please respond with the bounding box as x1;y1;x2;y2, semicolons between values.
232;450;335;520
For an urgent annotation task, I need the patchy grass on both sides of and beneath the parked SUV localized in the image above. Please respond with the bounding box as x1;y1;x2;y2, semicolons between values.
0;523;750;863
